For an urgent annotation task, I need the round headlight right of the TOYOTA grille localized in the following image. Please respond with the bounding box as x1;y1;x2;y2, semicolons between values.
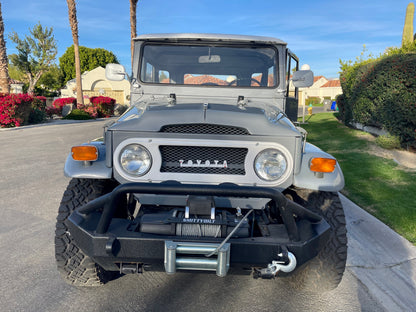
254;149;287;181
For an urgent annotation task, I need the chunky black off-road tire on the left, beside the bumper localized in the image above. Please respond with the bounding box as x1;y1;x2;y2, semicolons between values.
55;179;115;286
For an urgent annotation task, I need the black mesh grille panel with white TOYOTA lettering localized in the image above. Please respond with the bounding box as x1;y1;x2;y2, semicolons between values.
159;145;248;175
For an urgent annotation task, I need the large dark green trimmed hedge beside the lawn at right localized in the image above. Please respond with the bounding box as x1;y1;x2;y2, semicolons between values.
337;53;416;147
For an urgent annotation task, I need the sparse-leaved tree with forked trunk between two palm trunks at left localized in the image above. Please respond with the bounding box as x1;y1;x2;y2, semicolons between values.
9;23;58;94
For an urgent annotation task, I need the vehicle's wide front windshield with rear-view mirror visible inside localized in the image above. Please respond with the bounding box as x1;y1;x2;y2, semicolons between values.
140;44;278;88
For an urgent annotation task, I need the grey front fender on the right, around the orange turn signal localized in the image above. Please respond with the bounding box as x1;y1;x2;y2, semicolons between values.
293;143;344;192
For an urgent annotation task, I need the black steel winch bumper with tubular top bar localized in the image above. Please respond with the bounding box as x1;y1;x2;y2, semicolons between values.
66;183;330;273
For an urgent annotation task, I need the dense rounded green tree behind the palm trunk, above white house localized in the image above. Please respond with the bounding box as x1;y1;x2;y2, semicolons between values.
59;46;118;83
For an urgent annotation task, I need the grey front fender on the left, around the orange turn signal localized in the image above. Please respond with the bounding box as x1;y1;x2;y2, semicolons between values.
64;142;113;179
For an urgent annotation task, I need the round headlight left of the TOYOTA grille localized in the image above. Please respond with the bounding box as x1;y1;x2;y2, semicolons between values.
120;144;152;177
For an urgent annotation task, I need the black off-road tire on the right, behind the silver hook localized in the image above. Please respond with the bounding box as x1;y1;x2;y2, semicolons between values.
287;189;347;292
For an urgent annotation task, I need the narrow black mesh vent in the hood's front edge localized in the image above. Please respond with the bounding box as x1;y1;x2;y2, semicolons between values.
160;124;250;135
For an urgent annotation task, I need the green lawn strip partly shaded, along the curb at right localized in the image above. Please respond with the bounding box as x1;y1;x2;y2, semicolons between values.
302;113;416;244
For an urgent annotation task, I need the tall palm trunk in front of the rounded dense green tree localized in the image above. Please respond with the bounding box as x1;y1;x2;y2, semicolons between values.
66;0;84;104
